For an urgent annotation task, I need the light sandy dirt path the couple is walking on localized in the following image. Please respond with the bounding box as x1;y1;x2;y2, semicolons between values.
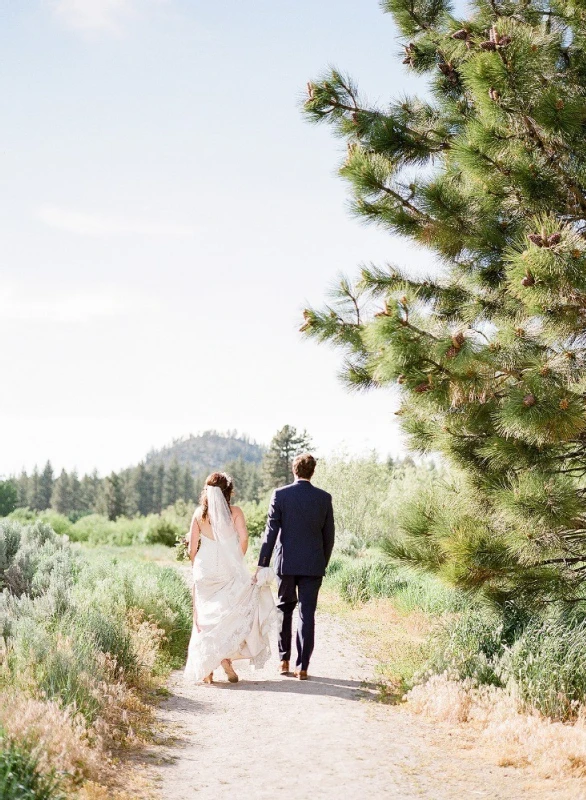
152;614;586;800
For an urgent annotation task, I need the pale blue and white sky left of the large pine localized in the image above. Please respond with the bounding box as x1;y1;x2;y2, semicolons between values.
0;0;432;475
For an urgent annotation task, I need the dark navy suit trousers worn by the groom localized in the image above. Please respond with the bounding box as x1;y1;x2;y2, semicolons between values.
277;575;323;670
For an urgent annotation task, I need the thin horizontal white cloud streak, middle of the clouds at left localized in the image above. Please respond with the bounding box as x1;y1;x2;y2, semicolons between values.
38;206;196;239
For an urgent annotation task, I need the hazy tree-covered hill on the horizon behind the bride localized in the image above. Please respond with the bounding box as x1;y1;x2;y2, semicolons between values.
146;431;264;477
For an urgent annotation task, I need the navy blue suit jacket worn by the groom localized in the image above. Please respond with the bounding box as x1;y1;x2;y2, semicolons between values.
258;481;335;575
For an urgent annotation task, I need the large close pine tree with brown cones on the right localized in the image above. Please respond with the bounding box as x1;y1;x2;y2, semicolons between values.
302;0;586;603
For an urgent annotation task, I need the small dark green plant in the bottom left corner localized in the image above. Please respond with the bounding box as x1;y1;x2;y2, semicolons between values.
0;729;63;800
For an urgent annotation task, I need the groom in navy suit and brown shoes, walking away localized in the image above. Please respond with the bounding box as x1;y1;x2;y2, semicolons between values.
258;453;335;681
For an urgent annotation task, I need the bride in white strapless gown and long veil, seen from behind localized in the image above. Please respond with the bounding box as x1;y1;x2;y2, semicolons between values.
185;472;279;683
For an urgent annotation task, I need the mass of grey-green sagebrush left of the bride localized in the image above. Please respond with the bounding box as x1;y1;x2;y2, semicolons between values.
0;521;192;721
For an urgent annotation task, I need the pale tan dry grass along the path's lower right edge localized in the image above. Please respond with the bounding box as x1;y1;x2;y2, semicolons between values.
407;675;586;778
